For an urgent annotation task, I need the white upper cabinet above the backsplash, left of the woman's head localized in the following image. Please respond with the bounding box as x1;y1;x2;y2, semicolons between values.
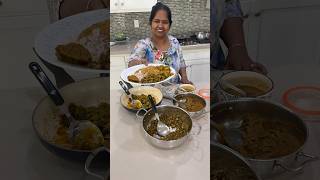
110;0;157;13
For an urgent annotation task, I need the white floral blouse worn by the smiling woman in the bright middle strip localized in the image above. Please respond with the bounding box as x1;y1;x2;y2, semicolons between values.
128;35;186;82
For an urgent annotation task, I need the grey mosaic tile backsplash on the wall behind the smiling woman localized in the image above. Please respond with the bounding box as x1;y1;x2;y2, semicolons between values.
110;0;210;40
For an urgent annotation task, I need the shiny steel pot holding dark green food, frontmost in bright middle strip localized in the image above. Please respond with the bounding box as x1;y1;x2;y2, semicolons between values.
137;105;192;149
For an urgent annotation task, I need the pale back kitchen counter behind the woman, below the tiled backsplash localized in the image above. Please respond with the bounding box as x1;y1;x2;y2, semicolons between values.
110;40;210;56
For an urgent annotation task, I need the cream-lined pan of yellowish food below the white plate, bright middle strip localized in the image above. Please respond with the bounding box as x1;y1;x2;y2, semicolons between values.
120;86;163;112
